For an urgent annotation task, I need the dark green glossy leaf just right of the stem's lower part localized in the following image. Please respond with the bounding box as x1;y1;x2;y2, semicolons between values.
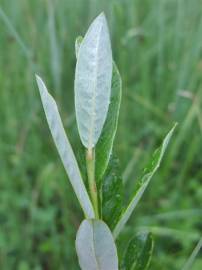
102;157;123;230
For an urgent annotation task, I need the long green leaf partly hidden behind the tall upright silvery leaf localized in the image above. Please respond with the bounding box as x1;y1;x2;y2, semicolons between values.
95;63;122;182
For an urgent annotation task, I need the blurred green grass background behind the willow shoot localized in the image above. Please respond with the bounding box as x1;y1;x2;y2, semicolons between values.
0;0;202;270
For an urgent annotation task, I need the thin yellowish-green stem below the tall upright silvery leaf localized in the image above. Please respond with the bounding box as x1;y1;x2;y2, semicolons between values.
86;149;99;219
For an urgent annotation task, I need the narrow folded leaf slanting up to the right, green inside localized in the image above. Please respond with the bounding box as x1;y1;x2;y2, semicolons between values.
113;124;176;238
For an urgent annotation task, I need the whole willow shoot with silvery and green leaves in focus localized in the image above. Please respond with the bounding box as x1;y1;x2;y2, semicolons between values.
36;13;175;270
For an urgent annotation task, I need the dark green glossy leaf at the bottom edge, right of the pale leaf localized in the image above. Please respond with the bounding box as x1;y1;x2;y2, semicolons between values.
123;232;154;270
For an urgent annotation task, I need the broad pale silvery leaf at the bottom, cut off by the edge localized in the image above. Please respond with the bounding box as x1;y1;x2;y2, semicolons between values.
76;219;118;270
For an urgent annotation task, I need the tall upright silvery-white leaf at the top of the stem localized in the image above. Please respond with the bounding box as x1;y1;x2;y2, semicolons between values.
75;13;112;149
